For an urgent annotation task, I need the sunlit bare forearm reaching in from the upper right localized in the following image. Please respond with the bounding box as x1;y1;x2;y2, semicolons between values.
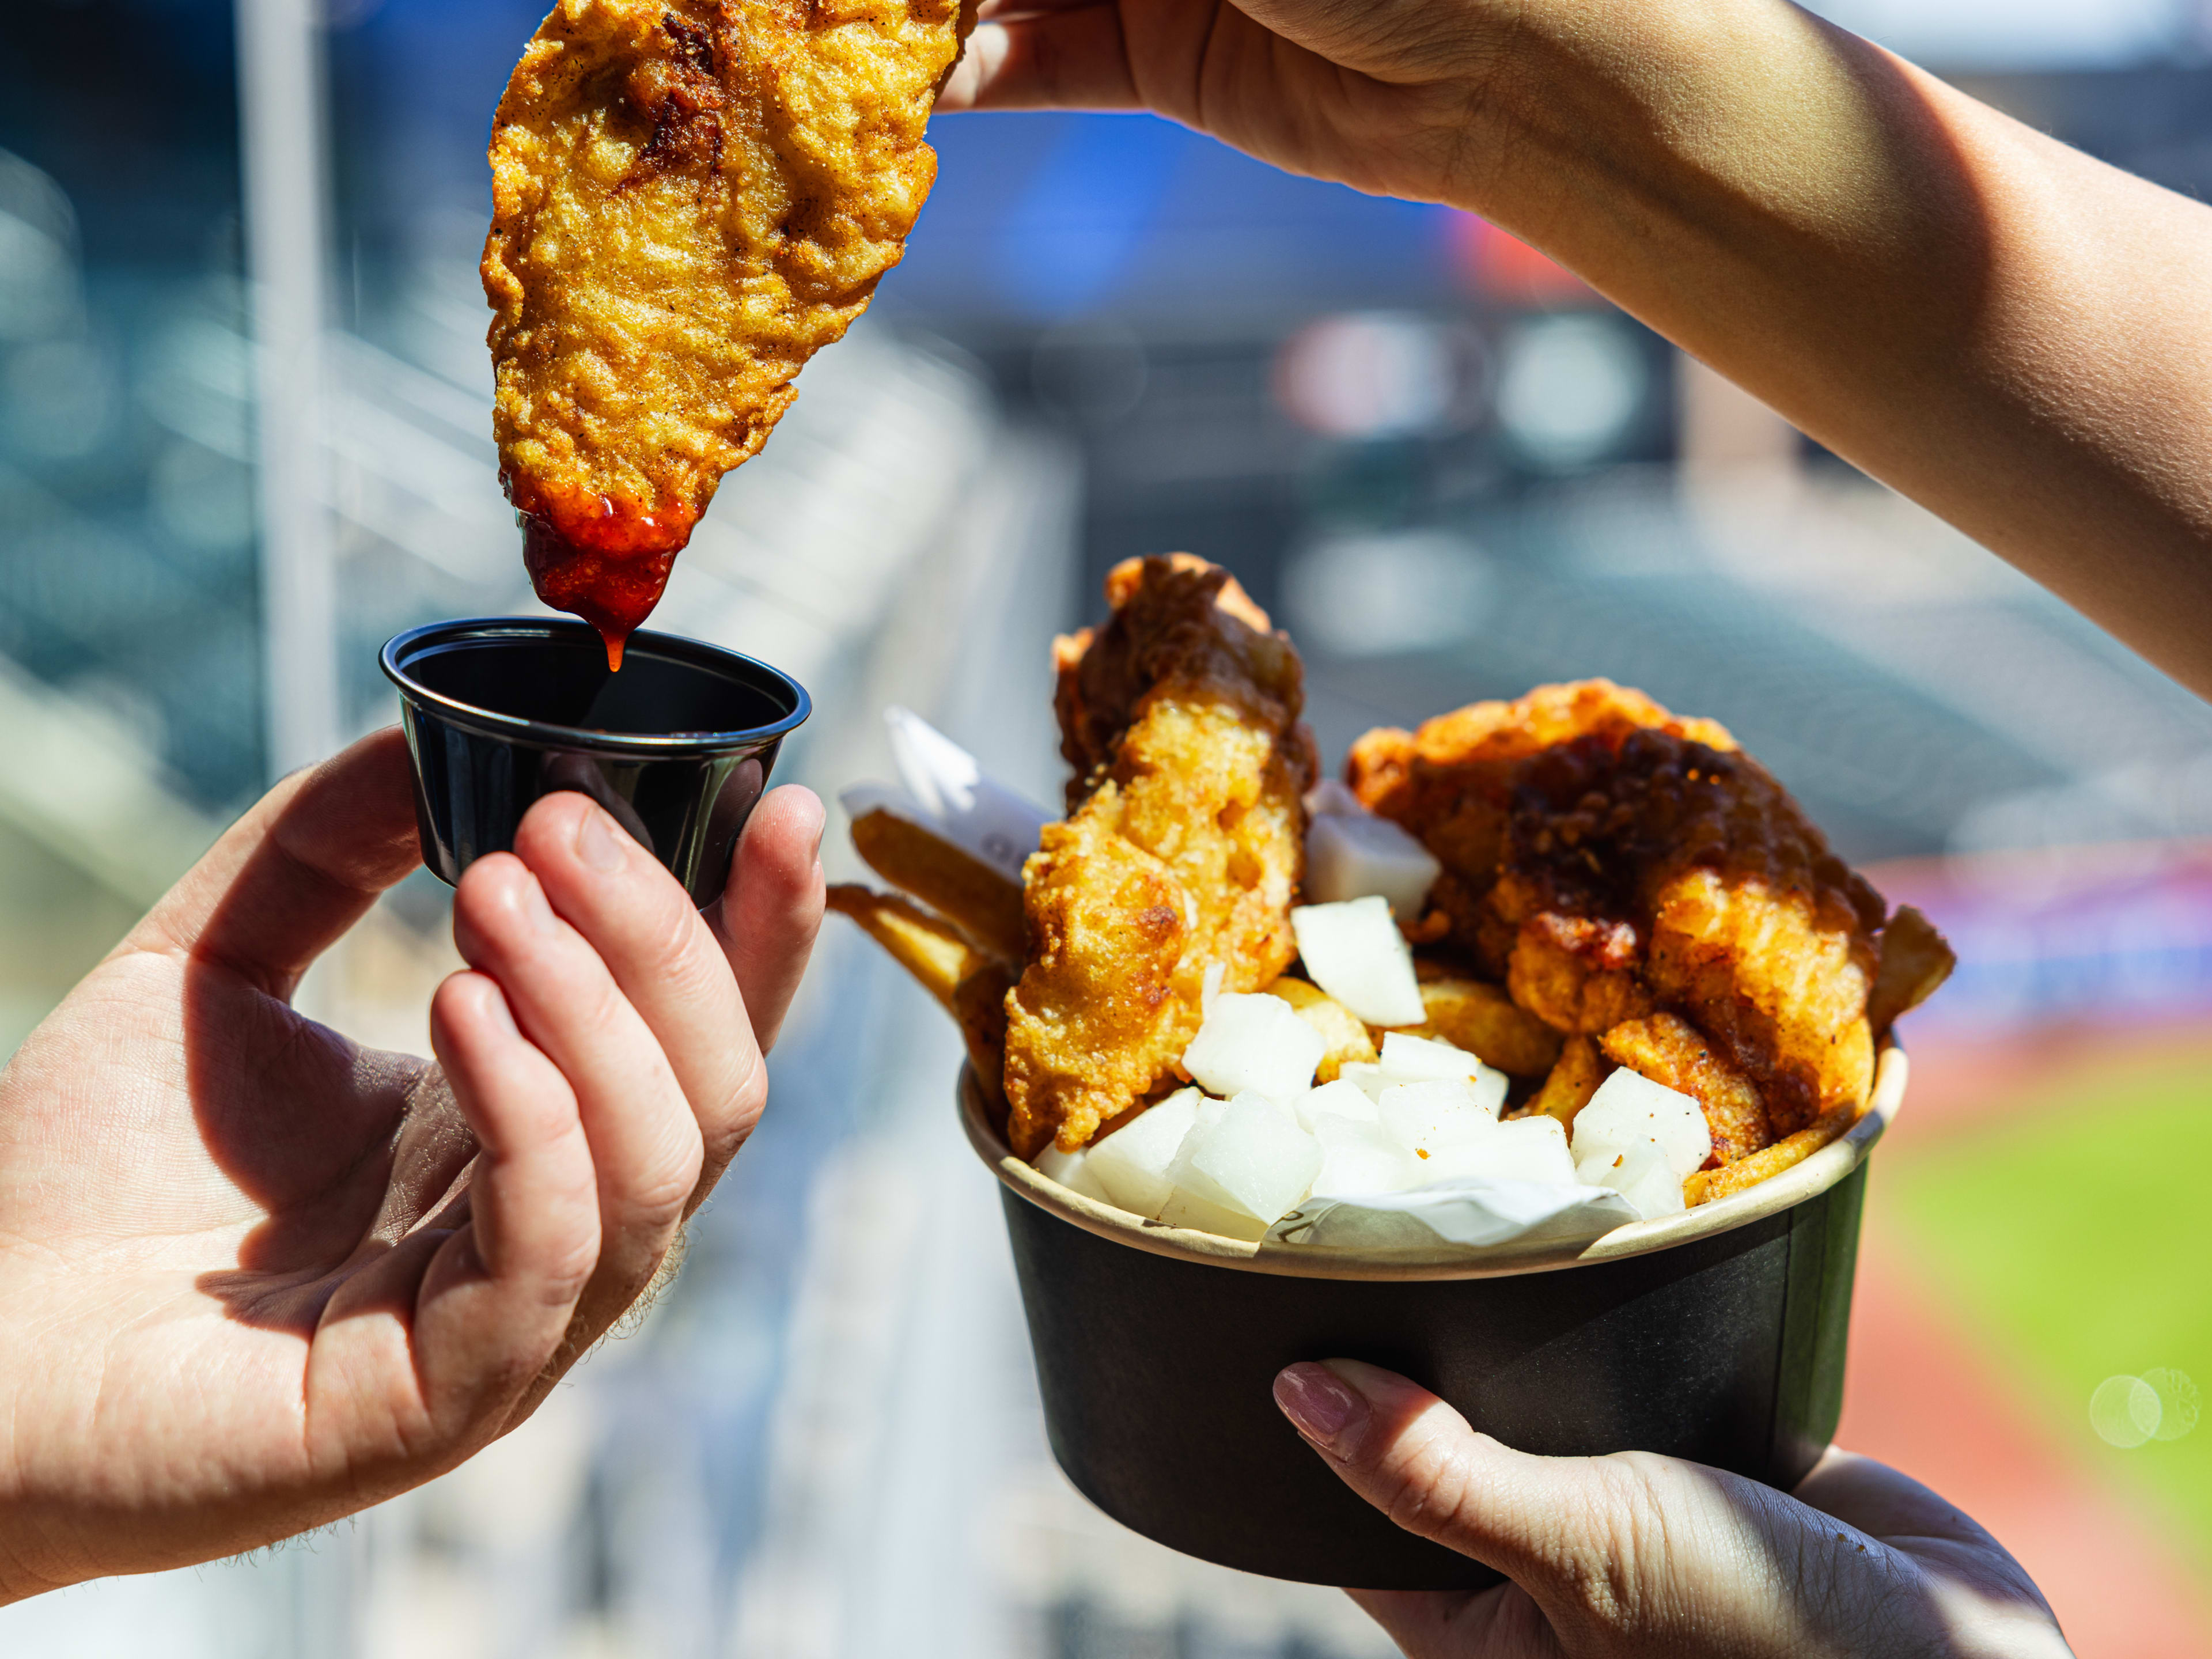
1456;0;2212;692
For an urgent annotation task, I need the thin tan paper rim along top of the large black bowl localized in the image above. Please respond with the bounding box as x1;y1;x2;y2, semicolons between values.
958;1040;1909;1279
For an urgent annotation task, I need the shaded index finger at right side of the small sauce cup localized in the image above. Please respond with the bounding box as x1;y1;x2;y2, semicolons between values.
714;785;823;1053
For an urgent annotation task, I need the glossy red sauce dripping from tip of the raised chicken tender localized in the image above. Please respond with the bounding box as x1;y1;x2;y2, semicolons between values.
502;478;697;671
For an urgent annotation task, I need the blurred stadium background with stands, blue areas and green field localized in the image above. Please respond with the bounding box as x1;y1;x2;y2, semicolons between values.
0;0;2212;1659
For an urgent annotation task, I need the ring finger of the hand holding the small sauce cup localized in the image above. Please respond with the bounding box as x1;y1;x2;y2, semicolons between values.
453;854;701;1320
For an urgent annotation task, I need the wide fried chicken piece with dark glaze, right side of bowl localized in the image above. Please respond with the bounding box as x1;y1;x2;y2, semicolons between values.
1347;681;1951;1161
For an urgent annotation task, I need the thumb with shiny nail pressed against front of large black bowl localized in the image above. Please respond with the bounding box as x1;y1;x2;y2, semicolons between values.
1274;1361;1666;1650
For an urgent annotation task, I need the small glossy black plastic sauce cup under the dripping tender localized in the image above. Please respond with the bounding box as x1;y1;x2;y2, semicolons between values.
378;617;812;907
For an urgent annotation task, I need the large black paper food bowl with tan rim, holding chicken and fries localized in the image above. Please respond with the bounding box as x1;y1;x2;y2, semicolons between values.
960;1046;1904;1590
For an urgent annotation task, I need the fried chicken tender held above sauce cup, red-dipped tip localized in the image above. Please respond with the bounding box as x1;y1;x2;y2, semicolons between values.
482;0;974;655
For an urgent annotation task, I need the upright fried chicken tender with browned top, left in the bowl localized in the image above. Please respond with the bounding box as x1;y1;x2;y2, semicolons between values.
1006;555;1314;1157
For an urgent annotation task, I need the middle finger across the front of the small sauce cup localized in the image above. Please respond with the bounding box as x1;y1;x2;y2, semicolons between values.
516;792;767;1206
